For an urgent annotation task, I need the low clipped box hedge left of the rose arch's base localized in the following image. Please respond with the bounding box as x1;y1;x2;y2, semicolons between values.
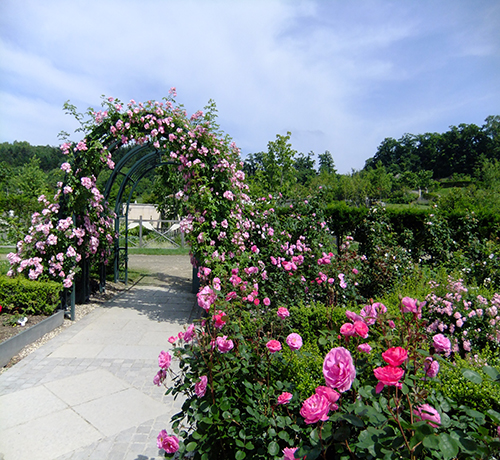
0;276;63;315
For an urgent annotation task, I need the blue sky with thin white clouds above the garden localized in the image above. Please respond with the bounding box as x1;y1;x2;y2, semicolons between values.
0;0;500;173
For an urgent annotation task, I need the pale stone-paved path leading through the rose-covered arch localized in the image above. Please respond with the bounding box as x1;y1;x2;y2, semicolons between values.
0;256;200;460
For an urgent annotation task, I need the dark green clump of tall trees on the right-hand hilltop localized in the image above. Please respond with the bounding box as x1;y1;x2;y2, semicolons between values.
365;115;500;180
